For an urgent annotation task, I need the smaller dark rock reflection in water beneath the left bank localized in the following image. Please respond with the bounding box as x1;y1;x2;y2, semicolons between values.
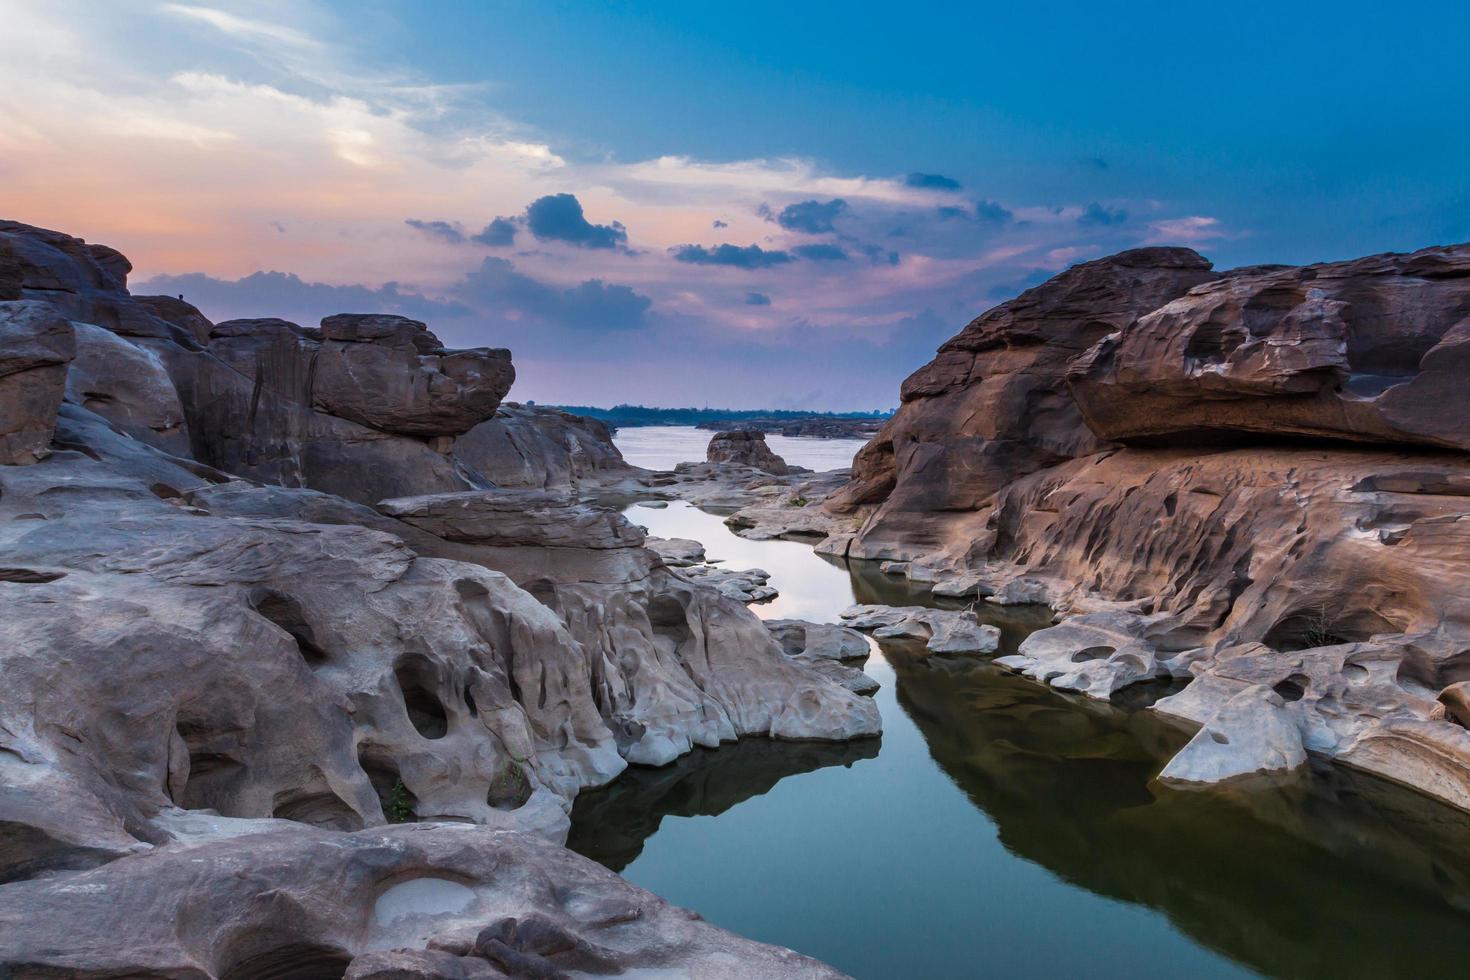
566;738;881;871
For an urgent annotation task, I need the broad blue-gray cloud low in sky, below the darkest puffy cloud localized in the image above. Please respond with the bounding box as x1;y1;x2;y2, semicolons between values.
451;257;653;331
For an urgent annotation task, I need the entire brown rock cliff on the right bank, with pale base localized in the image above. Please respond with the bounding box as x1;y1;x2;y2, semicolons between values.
825;239;1470;808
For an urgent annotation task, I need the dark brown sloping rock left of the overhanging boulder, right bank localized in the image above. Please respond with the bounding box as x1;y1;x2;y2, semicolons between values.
829;248;1214;558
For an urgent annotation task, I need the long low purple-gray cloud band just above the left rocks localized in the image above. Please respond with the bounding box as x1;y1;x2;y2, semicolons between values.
132;272;467;326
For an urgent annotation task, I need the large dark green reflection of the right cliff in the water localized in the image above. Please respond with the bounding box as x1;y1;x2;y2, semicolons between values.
888;649;1470;977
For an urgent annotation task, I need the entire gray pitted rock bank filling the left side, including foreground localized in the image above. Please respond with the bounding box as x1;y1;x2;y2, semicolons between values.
0;223;879;977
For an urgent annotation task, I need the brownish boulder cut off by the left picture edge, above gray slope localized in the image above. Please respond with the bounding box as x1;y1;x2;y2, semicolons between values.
0;300;76;464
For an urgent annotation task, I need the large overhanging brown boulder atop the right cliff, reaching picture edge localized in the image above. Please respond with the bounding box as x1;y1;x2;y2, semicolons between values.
1069;245;1470;450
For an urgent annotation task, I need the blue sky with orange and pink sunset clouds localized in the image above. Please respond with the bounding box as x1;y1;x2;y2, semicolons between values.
0;0;1470;410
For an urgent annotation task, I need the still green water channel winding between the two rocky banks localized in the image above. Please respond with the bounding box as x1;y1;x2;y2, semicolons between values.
570;504;1470;979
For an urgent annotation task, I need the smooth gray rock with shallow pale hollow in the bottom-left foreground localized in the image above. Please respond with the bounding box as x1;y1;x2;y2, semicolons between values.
0;824;841;980
